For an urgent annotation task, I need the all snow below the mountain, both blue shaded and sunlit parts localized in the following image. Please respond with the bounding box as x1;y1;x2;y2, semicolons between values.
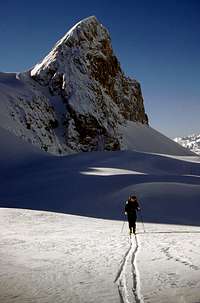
0;126;200;303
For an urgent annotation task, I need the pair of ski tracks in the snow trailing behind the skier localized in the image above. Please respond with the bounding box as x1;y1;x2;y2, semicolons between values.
114;235;143;303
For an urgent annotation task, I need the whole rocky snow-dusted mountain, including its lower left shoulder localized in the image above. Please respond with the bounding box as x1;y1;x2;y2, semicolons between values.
0;16;148;154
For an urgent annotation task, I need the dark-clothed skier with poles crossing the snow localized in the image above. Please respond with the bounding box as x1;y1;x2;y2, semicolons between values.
125;196;140;235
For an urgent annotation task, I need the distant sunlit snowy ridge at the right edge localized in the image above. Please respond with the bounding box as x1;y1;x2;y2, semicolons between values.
174;134;200;155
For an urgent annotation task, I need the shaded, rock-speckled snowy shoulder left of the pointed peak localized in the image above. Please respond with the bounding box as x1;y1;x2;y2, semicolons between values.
0;73;64;153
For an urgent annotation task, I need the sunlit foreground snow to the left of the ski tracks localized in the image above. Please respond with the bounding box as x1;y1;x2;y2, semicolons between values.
0;209;128;303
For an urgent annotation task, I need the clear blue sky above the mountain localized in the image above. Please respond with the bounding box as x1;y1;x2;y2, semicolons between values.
0;0;200;137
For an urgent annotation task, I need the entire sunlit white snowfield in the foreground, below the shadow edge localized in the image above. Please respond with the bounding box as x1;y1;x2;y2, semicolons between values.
0;208;200;303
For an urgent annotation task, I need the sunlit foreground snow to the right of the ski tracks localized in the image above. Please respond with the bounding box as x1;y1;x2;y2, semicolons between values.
137;229;200;303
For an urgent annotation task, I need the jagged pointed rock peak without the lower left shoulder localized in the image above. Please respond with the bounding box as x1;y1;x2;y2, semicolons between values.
30;17;148;151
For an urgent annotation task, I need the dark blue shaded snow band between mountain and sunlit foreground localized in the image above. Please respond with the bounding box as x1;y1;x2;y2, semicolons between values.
0;129;200;224
